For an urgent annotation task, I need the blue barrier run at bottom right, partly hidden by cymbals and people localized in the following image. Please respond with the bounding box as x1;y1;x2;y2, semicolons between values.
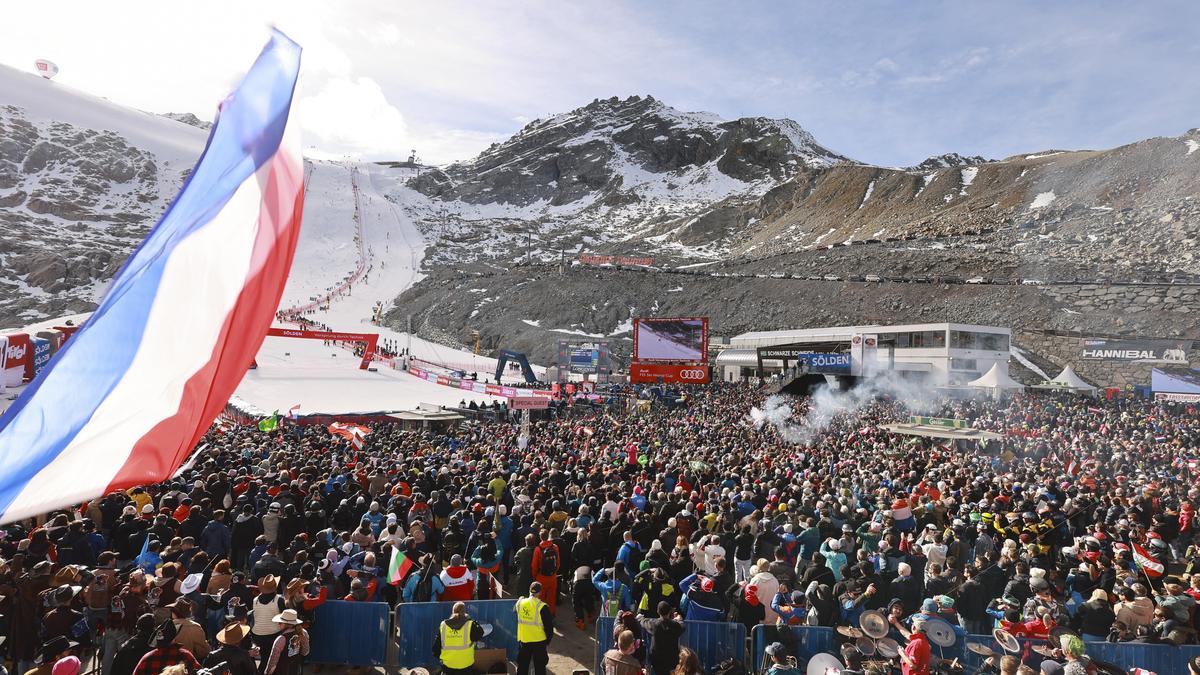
748;626;1200;675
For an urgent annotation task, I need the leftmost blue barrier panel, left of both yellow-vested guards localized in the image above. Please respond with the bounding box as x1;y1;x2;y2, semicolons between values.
308;601;391;665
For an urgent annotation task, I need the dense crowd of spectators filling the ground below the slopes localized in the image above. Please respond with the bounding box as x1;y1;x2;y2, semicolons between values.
0;384;1200;675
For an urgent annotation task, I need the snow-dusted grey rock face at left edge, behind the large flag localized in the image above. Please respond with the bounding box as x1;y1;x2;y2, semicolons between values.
0;100;190;328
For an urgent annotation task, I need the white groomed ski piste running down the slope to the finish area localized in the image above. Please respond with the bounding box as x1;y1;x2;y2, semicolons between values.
235;162;537;414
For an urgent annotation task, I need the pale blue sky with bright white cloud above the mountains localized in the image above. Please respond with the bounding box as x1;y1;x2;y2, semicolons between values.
0;0;1200;166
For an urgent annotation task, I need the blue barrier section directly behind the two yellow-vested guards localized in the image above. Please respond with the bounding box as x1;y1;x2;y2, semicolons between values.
396;599;517;668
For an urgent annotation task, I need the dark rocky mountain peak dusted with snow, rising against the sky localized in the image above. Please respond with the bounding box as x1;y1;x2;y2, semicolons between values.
413;96;845;207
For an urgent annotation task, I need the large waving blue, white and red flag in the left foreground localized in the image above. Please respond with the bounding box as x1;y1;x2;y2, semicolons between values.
0;31;304;522
